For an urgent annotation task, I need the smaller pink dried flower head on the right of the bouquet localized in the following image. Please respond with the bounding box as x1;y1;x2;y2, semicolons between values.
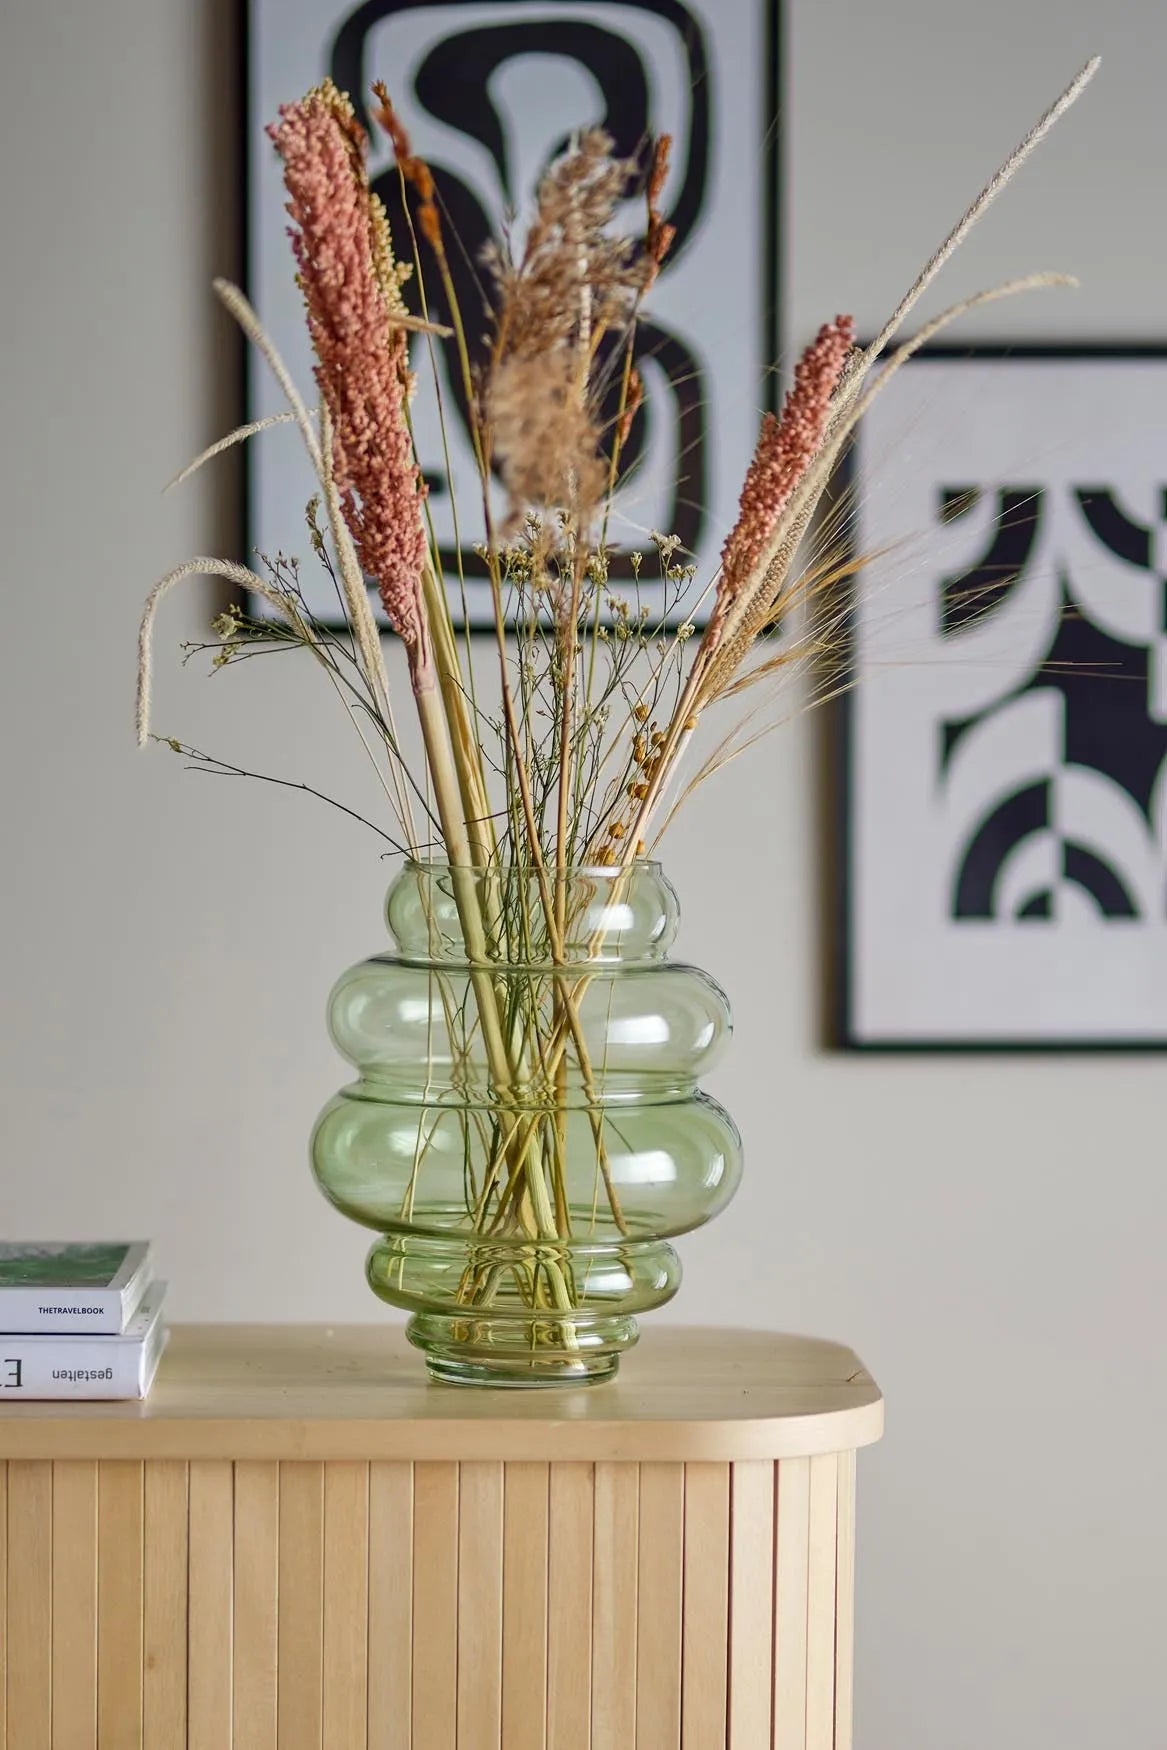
717;317;856;606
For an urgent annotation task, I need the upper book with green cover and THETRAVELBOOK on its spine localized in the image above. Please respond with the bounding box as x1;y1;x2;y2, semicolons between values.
0;1239;150;1335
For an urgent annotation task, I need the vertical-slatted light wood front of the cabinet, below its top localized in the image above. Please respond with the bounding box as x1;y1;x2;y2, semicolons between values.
0;1453;854;1750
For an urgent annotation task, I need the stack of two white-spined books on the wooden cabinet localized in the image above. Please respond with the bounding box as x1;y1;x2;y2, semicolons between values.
0;1241;166;1414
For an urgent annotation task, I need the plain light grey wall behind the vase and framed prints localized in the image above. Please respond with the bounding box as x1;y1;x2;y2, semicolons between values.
0;0;1167;1750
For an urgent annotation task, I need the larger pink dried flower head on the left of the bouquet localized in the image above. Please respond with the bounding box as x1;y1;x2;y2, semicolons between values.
268;81;430;686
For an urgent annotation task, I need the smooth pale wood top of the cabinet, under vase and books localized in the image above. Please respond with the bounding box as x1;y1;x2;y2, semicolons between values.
0;1325;884;1461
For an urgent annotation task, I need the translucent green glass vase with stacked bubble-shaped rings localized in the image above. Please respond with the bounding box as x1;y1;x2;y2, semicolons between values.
311;863;742;1386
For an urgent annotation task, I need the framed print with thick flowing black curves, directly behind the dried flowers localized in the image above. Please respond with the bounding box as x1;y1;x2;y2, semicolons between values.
248;0;779;625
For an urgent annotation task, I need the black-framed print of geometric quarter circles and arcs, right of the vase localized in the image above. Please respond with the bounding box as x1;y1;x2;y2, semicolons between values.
843;350;1167;1047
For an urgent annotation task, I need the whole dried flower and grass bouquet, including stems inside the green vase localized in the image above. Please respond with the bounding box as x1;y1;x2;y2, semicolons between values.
138;51;1097;1349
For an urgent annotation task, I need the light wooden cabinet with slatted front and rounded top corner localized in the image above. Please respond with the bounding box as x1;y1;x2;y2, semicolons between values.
0;1327;882;1750
